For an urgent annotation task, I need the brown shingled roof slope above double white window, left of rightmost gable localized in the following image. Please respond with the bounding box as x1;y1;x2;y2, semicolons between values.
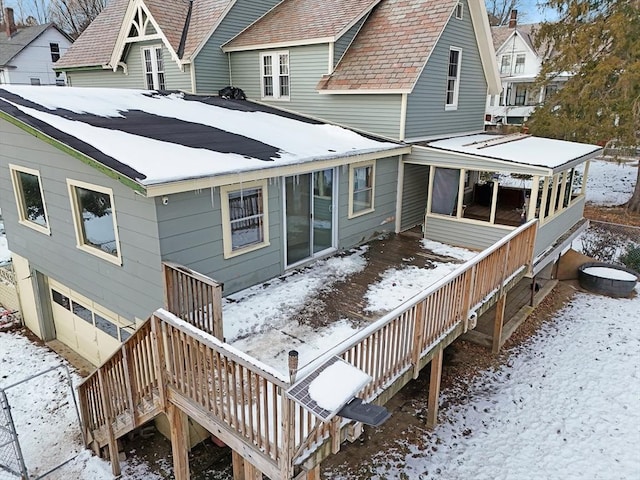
223;0;380;52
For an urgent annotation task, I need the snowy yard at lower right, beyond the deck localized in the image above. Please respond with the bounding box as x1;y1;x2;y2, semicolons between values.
325;287;640;480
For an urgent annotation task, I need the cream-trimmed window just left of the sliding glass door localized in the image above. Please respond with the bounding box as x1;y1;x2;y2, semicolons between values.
220;180;269;258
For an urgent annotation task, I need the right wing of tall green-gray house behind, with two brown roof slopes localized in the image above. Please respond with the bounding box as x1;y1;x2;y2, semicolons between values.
222;0;500;142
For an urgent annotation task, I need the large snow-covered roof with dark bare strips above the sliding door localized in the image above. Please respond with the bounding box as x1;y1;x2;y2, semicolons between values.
0;86;410;194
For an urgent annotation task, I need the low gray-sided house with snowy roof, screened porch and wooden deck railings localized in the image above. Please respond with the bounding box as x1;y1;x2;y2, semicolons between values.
0;86;600;479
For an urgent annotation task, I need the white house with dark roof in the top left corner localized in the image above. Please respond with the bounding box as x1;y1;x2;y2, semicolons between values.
0;8;73;85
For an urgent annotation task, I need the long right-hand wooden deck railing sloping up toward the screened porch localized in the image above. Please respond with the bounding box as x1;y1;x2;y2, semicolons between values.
288;220;537;458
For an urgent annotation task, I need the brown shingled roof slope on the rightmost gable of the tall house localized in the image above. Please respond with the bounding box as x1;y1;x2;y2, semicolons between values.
318;0;458;91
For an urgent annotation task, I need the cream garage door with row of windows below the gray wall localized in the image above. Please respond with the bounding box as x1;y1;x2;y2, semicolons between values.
49;279;135;366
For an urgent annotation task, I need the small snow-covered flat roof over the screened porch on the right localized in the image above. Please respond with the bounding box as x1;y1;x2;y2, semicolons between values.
424;133;602;174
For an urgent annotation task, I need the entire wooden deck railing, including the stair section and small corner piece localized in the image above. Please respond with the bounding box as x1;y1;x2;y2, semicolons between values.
80;221;536;478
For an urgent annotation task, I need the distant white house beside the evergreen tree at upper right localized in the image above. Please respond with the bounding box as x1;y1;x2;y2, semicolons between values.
485;10;571;128
